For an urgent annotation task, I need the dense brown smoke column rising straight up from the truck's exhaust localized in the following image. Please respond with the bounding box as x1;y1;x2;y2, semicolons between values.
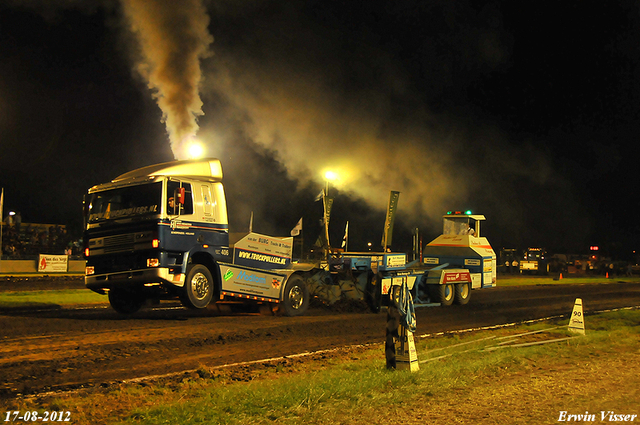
122;0;213;159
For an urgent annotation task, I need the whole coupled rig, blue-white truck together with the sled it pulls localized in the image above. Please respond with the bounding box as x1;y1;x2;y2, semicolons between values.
83;159;496;316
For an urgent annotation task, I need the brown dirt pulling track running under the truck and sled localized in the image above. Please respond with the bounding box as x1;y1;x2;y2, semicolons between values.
0;279;640;399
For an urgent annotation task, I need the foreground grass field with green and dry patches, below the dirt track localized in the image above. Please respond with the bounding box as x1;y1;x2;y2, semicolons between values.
6;310;640;424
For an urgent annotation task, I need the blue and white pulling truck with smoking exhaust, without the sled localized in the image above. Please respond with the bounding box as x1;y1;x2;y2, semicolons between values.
84;159;309;315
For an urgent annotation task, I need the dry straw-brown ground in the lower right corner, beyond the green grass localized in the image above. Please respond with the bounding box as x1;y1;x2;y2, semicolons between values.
380;344;640;425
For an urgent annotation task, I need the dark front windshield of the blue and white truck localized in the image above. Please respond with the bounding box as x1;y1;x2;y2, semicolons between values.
87;182;162;223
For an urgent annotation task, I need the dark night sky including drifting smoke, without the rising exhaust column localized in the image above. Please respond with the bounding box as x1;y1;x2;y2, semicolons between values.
0;0;640;257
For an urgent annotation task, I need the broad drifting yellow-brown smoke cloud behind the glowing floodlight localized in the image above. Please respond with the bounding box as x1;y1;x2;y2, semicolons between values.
202;3;470;227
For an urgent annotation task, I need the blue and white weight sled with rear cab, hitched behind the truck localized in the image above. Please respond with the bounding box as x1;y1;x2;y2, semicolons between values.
307;211;497;312
